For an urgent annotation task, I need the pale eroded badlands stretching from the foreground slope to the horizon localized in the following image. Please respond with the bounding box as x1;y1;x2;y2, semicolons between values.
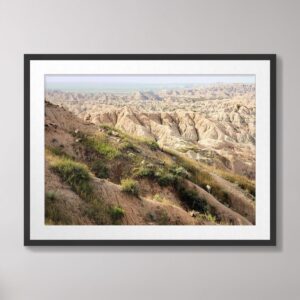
47;85;256;179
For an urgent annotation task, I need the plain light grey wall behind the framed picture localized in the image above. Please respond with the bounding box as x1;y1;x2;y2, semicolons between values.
0;0;300;300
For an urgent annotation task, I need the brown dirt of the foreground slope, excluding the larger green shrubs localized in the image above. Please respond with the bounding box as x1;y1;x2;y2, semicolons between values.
45;102;255;225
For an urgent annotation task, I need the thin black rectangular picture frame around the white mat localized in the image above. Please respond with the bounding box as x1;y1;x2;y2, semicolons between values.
24;54;276;246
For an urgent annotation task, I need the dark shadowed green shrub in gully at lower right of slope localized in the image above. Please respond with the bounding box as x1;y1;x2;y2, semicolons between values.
177;185;209;213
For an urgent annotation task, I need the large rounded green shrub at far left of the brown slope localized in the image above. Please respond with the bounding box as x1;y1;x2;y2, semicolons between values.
51;158;92;199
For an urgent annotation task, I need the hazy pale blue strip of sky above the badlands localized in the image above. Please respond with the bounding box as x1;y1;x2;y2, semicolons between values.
45;75;255;92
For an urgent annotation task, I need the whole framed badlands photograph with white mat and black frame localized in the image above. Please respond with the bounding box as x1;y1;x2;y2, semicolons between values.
24;54;276;246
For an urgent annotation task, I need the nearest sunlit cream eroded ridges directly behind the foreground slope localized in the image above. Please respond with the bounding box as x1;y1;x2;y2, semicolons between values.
82;101;255;179
